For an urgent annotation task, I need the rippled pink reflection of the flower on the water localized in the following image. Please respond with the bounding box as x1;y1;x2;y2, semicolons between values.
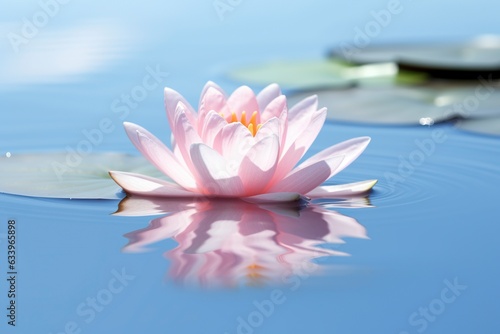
115;197;370;287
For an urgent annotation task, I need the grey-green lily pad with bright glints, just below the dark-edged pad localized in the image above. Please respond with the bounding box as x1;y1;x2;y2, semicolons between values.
289;83;500;125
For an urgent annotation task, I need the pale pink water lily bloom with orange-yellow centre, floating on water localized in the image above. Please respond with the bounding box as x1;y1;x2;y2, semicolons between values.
110;82;376;202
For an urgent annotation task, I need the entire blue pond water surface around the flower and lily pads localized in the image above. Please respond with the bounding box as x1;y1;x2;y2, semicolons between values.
0;0;500;334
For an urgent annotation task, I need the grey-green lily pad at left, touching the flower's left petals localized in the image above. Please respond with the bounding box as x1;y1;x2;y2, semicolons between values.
0;153;162;199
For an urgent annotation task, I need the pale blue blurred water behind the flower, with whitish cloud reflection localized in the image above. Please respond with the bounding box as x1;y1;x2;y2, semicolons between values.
0;0;500;151
